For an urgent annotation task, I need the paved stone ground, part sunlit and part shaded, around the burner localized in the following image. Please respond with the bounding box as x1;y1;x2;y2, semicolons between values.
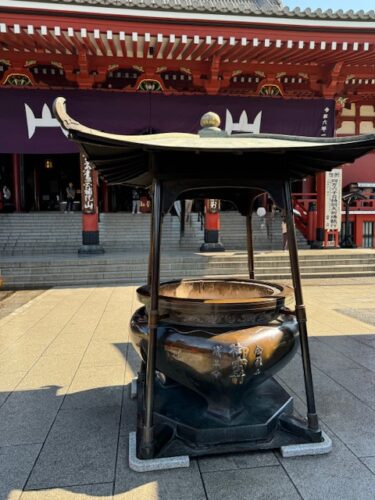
0;278;375;500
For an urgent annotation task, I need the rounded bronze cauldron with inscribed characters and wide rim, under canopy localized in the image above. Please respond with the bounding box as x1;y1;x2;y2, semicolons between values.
131;279;298;420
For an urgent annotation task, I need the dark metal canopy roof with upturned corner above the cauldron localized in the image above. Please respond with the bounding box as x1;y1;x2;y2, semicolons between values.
54;97;375;189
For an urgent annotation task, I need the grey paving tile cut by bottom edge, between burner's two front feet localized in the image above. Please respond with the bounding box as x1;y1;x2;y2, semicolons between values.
202;465;301;500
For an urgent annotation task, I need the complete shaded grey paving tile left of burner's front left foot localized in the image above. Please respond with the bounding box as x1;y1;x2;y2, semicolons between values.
26;406;120;490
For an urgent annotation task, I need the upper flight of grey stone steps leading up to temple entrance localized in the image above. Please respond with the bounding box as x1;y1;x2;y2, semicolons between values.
0;212;306;256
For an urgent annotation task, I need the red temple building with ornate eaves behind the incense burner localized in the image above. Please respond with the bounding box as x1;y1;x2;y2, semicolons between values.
0;0;375;247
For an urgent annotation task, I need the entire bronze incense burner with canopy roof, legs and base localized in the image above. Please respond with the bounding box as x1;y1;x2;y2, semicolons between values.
55;98;375;459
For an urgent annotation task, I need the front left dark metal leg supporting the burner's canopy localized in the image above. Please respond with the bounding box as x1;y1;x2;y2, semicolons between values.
140;179;162;458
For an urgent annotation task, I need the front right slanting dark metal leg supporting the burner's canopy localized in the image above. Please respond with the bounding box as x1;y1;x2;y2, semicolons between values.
283;181;319;430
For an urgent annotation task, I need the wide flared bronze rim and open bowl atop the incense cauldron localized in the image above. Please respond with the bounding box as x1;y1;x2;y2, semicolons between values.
137;278;293;328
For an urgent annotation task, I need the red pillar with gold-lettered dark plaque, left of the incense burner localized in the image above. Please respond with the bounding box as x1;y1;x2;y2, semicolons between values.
78;154;104;255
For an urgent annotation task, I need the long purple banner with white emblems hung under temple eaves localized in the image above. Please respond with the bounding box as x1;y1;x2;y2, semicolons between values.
0;89;335;154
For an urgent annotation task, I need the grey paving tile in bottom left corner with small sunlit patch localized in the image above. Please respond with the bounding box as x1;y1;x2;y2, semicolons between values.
0;444;42;500
